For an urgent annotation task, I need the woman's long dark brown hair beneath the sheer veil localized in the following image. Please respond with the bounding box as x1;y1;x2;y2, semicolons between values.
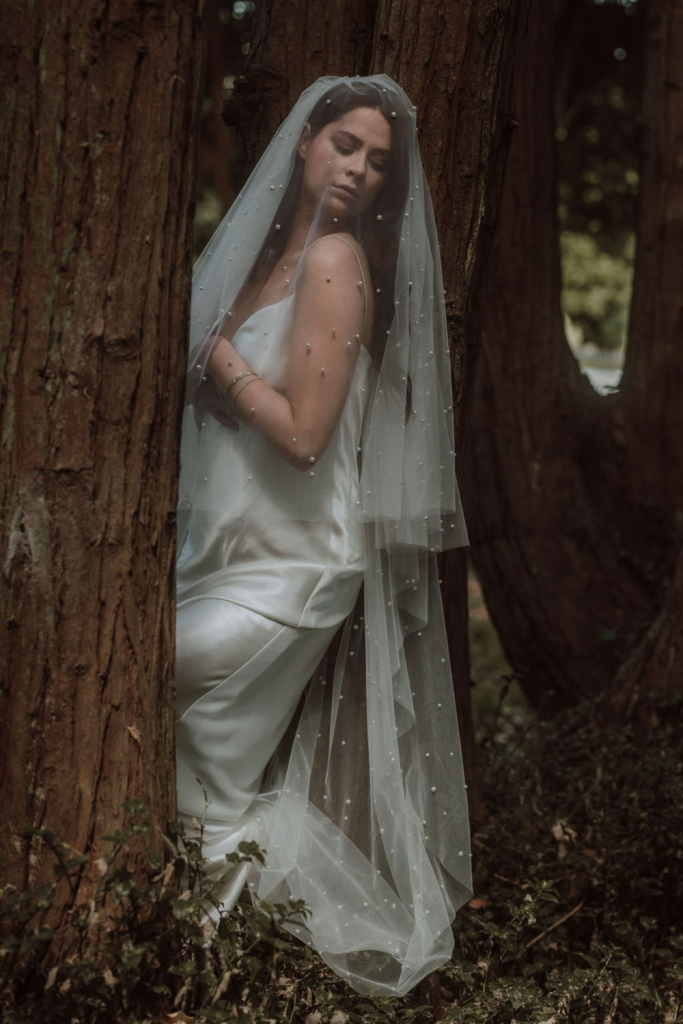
250;81;411;380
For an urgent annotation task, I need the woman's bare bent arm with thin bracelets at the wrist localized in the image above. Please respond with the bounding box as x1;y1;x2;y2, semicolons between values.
209;236;372;470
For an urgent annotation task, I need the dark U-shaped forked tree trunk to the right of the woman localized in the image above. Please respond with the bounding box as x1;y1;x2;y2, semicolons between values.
464;0;683;706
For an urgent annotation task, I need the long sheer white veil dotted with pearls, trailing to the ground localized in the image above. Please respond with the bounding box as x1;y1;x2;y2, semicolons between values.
179;75;472;995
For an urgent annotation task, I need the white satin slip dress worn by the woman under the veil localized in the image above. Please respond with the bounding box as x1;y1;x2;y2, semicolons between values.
176;251;372;909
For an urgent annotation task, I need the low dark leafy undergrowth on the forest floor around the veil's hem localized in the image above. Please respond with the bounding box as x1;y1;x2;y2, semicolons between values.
0;696;683;1024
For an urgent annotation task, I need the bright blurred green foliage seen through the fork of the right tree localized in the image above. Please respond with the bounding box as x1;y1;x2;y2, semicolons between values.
560;231;634;349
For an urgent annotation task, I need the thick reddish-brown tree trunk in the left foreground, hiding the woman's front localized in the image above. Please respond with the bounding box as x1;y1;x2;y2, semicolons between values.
0;0;202;941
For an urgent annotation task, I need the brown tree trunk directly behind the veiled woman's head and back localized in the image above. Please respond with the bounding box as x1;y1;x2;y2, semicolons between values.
226;0;528;821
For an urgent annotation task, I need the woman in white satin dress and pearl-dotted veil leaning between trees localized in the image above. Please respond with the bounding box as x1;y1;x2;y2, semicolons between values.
177;75;471;995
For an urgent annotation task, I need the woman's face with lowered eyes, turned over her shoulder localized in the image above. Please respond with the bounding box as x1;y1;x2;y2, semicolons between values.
299;106;391;219
